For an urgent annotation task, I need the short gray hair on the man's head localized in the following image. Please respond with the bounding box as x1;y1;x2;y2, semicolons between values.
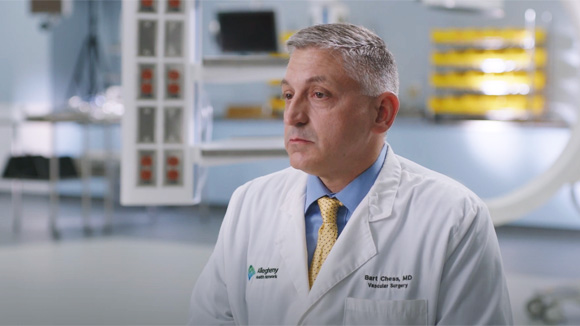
286;24;399;96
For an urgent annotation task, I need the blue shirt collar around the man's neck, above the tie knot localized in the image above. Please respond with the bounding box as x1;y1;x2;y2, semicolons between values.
304;144;387;213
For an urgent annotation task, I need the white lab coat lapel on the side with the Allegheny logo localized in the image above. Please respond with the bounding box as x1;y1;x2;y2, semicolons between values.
276;177;309;301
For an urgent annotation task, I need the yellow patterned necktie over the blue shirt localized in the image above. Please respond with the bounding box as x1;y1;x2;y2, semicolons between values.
308;196;342;287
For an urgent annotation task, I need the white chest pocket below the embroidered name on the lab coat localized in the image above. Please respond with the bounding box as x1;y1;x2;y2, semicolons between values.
344;298;427;325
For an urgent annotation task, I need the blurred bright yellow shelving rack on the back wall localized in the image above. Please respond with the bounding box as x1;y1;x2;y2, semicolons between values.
427;28;547;119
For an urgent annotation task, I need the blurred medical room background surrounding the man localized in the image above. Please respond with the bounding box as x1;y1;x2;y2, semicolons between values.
0;0;580;325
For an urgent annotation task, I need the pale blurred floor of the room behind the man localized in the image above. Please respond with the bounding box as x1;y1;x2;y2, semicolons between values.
0;193;580;325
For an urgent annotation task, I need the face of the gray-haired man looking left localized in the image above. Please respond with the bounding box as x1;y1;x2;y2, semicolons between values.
282;48;378;178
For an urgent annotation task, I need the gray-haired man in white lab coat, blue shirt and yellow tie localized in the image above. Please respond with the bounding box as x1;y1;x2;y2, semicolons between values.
190;24;512;325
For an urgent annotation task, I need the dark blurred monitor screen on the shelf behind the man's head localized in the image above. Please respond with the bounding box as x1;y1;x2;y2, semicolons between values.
218;11;278;53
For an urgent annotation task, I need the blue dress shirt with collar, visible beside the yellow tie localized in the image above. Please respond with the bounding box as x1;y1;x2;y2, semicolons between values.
304;145;387;268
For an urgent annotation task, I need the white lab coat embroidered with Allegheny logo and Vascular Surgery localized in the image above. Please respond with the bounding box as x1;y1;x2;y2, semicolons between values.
190;148;513;325
